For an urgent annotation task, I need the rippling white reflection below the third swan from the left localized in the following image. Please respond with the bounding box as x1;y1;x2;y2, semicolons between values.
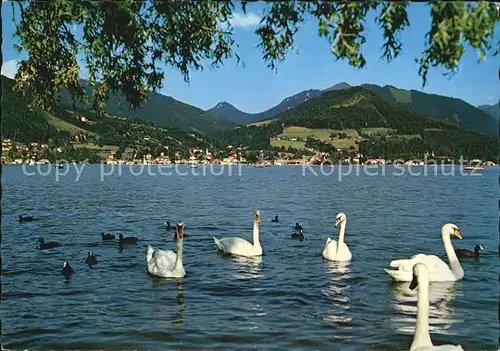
321;261;352;329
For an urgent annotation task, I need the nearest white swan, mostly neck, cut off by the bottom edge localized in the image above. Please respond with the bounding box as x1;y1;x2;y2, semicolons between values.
410;262;464;351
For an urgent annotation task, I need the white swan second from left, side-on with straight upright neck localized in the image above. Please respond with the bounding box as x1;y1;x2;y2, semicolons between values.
214;210;262;257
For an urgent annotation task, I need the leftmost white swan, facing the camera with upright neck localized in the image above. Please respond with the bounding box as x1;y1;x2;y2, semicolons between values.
146;222;186;278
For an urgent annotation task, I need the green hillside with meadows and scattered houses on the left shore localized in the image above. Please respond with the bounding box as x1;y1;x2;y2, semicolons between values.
1;76;219;163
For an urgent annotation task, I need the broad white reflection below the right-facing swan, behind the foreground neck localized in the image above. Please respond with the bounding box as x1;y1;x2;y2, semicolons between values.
391;282;464;335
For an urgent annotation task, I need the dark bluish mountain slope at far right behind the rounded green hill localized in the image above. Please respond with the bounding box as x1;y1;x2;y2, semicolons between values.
362;84;498;136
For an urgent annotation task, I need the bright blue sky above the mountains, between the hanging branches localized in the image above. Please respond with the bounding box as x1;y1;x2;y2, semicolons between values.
2;2;500;113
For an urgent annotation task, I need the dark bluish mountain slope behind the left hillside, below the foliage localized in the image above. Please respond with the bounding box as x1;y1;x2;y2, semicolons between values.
61;82;234;135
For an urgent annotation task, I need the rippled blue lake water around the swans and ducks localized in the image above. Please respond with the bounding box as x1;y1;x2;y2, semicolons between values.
1;165;500;350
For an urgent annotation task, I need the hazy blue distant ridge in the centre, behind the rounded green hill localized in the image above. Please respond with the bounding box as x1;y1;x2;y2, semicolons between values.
206;82;350;124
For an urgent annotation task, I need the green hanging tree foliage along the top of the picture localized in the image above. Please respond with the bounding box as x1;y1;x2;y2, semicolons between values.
8;0;499;109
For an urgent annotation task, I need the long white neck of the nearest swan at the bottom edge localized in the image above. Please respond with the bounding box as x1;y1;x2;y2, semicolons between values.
410;274;432;350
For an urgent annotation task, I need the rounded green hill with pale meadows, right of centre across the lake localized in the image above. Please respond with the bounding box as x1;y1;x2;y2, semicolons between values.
220;87;498;160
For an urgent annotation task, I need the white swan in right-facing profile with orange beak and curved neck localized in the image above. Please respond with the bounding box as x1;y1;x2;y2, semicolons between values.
384;223;464;282
